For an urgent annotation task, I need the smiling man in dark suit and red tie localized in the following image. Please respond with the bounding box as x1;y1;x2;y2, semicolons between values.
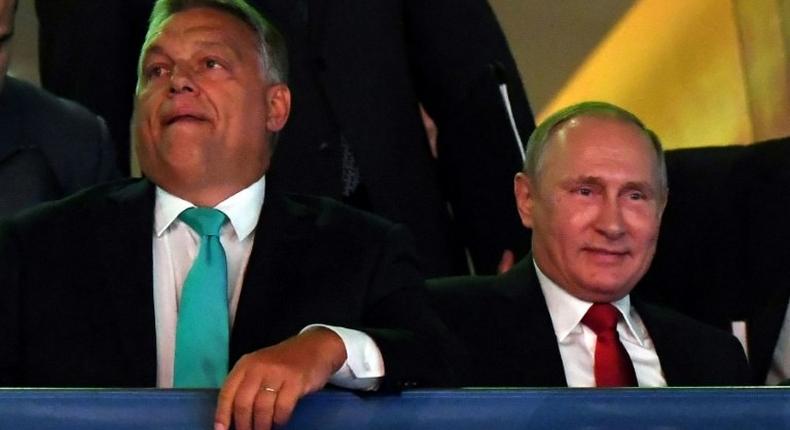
431;102;748;387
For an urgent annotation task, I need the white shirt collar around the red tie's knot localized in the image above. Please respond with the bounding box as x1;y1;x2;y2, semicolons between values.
532;260;646;346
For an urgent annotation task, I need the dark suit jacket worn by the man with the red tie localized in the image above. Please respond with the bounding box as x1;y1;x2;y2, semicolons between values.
428;258;748;387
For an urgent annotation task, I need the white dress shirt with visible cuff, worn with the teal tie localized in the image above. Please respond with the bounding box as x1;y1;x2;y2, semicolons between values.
153;177;384;389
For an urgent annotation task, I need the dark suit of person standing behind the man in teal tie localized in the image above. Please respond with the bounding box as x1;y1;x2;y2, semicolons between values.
36;0;534;276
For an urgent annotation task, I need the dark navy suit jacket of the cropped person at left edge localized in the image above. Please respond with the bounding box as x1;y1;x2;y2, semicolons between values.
0;76;118;217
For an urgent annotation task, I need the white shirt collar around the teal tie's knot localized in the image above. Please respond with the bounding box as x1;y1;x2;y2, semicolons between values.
154;176;266;241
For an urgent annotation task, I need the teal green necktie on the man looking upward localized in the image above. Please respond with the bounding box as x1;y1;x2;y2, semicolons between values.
173;208;229;388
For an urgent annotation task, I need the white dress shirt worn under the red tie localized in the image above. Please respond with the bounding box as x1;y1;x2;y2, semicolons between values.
533;262;667;387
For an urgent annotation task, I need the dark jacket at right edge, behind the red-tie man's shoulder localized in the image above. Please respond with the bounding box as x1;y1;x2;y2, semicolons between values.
634;137;790;385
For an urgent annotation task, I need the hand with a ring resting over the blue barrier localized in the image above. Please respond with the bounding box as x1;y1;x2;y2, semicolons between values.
214;327;346;430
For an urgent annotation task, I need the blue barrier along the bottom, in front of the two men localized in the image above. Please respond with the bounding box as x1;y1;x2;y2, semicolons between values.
0;387;790;430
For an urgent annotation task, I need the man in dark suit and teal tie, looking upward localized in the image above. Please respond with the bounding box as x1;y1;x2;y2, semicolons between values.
0;0;454;429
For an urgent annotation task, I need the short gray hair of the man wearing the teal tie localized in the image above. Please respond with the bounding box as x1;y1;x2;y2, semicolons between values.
137;0;288;85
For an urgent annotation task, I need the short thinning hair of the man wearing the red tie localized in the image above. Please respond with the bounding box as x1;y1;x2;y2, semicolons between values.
524;101;669;192
